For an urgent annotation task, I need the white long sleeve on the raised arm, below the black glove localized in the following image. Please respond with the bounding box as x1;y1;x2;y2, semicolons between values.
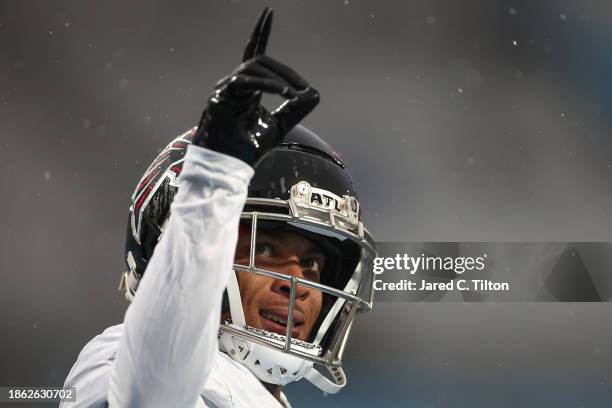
108;145;253;408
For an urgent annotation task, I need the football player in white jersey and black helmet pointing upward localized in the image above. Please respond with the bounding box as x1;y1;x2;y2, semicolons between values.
62;8;375;408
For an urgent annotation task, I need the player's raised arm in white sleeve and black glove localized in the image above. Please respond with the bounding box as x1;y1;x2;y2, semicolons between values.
108;9;318;408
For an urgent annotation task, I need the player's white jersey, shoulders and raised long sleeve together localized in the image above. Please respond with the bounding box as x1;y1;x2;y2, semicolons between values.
60;145;289;408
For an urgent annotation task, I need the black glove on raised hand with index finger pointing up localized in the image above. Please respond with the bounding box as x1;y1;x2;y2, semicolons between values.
193;7;319;166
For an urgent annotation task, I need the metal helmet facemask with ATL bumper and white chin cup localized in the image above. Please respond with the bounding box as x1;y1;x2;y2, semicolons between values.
220;182;375;393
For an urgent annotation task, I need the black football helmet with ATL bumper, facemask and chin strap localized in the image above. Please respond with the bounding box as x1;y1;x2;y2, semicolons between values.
120;125;376;393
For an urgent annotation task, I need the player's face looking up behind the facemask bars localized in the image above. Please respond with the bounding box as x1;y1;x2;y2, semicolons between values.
235;230;325;340
